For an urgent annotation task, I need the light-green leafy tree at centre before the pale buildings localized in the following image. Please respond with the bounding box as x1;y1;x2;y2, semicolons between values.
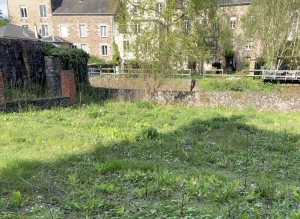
111;0;217;92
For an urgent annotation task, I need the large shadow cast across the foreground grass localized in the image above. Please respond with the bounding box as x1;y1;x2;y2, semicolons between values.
0;113;300;218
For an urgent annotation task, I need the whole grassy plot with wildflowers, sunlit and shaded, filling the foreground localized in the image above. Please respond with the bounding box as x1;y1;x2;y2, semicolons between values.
0;102;300;219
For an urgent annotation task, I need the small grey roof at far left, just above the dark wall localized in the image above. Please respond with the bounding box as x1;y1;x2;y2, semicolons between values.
0;24;38;41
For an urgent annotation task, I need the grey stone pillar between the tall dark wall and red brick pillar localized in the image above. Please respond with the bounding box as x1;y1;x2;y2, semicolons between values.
45;56;61;96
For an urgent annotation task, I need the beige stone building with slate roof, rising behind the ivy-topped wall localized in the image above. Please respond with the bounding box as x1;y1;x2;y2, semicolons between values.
7;0;117;60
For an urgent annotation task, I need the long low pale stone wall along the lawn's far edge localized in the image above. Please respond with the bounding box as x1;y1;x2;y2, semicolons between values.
98;88;300;112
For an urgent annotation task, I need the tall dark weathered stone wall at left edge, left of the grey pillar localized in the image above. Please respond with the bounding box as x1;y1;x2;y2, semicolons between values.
0;38;46;86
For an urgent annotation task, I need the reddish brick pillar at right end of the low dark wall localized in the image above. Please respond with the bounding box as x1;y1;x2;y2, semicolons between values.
60;70;76;105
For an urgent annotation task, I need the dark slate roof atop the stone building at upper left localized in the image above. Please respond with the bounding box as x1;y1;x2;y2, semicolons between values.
51;0;117;16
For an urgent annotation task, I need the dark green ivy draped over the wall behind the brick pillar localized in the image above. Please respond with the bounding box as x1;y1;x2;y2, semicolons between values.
42;42;89;88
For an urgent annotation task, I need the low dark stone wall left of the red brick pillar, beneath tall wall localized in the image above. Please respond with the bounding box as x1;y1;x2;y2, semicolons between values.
2;97;70;111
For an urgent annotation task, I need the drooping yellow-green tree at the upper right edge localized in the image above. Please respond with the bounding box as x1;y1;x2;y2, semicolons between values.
242;0;300;69
